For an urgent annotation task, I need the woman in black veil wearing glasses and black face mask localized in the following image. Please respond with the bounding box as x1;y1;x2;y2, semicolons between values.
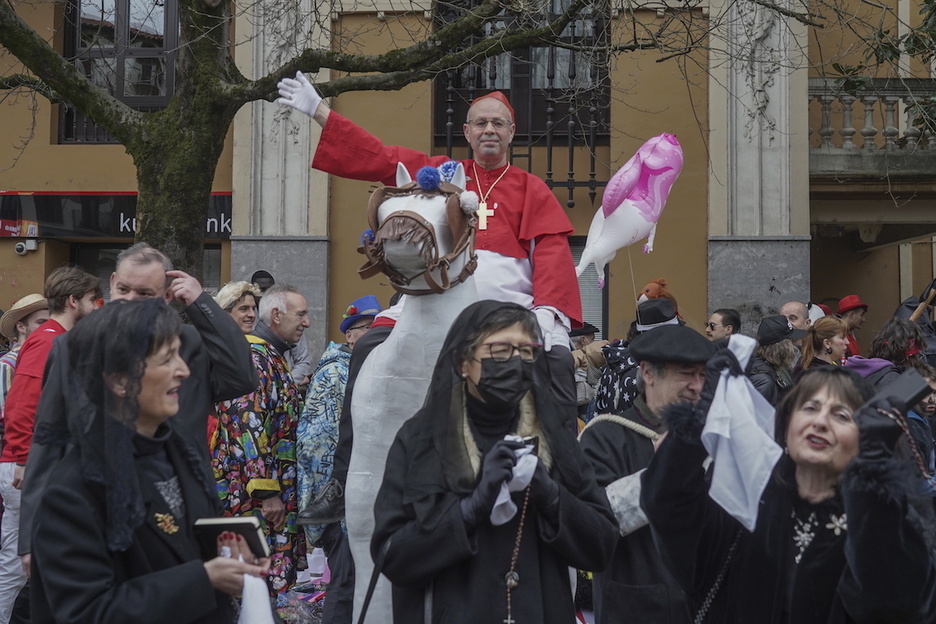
371;301;617;624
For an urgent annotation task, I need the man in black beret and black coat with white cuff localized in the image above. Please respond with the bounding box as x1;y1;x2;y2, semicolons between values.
581;325;715;624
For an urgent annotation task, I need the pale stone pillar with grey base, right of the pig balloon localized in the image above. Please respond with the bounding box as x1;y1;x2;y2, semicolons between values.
708;2;809;326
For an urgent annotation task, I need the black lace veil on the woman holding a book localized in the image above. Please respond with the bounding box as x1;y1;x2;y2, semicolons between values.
61;299;199;551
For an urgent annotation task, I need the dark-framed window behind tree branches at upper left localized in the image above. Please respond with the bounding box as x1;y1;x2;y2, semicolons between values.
59;0;179;143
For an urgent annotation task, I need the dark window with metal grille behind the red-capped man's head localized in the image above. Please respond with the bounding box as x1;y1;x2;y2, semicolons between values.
434;0;610;147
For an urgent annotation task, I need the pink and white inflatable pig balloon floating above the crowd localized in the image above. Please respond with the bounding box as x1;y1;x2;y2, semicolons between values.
575;133;683;288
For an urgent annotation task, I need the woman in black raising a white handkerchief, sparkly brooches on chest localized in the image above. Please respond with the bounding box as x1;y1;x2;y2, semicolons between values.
641;366;936;624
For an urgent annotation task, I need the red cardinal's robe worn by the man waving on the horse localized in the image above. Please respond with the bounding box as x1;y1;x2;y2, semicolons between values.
312;111;582;328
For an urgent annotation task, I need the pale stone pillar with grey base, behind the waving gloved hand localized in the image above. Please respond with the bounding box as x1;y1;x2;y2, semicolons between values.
231;0;329;356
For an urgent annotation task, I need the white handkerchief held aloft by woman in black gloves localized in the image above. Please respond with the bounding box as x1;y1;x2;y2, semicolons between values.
702;335;782;531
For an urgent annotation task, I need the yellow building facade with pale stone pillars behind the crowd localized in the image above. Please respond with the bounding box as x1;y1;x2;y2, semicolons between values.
0;1;936;350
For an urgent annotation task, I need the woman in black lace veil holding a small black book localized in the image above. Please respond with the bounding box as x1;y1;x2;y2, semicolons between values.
31;299;269;624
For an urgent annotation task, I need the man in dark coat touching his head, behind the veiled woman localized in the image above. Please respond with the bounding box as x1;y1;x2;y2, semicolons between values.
19;243;257;560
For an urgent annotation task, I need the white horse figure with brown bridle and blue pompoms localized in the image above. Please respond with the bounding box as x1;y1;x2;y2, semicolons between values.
345;163;478;624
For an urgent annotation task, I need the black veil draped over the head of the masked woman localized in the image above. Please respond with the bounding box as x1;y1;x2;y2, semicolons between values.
419;300;585;493
